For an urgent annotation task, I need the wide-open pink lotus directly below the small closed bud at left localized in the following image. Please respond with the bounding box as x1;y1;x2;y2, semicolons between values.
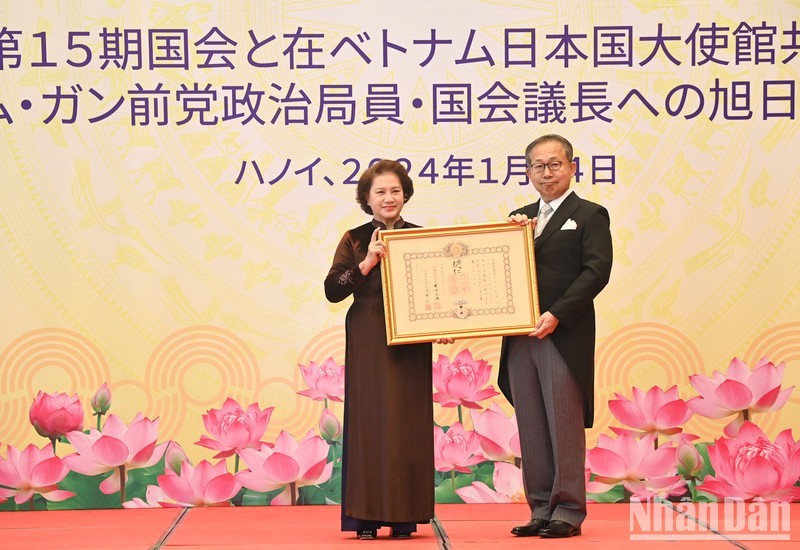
63;413;166;495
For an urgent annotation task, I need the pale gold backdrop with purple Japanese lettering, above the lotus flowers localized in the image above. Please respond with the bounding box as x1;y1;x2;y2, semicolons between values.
0;0;800;460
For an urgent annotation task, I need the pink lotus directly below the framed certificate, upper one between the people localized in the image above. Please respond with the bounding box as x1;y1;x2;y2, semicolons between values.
433;349;500;409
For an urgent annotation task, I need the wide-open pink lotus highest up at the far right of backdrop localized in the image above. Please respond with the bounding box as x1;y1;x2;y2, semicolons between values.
686;357;794;437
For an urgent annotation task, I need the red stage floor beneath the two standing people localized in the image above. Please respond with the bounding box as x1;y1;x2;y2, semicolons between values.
0;504;800;550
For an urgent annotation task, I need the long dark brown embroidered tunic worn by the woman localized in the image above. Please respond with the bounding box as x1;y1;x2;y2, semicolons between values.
325;220;434;531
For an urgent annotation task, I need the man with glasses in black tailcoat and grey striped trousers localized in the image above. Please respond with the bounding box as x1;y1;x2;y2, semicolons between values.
498;134;612;538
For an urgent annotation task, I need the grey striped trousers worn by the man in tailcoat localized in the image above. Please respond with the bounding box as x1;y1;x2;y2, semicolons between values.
508;336;586;527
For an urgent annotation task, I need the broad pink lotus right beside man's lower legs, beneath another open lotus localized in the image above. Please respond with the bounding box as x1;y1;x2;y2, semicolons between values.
586;434;685;500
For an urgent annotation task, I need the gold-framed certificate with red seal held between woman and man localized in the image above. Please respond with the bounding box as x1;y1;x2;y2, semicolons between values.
380;222;539;345
